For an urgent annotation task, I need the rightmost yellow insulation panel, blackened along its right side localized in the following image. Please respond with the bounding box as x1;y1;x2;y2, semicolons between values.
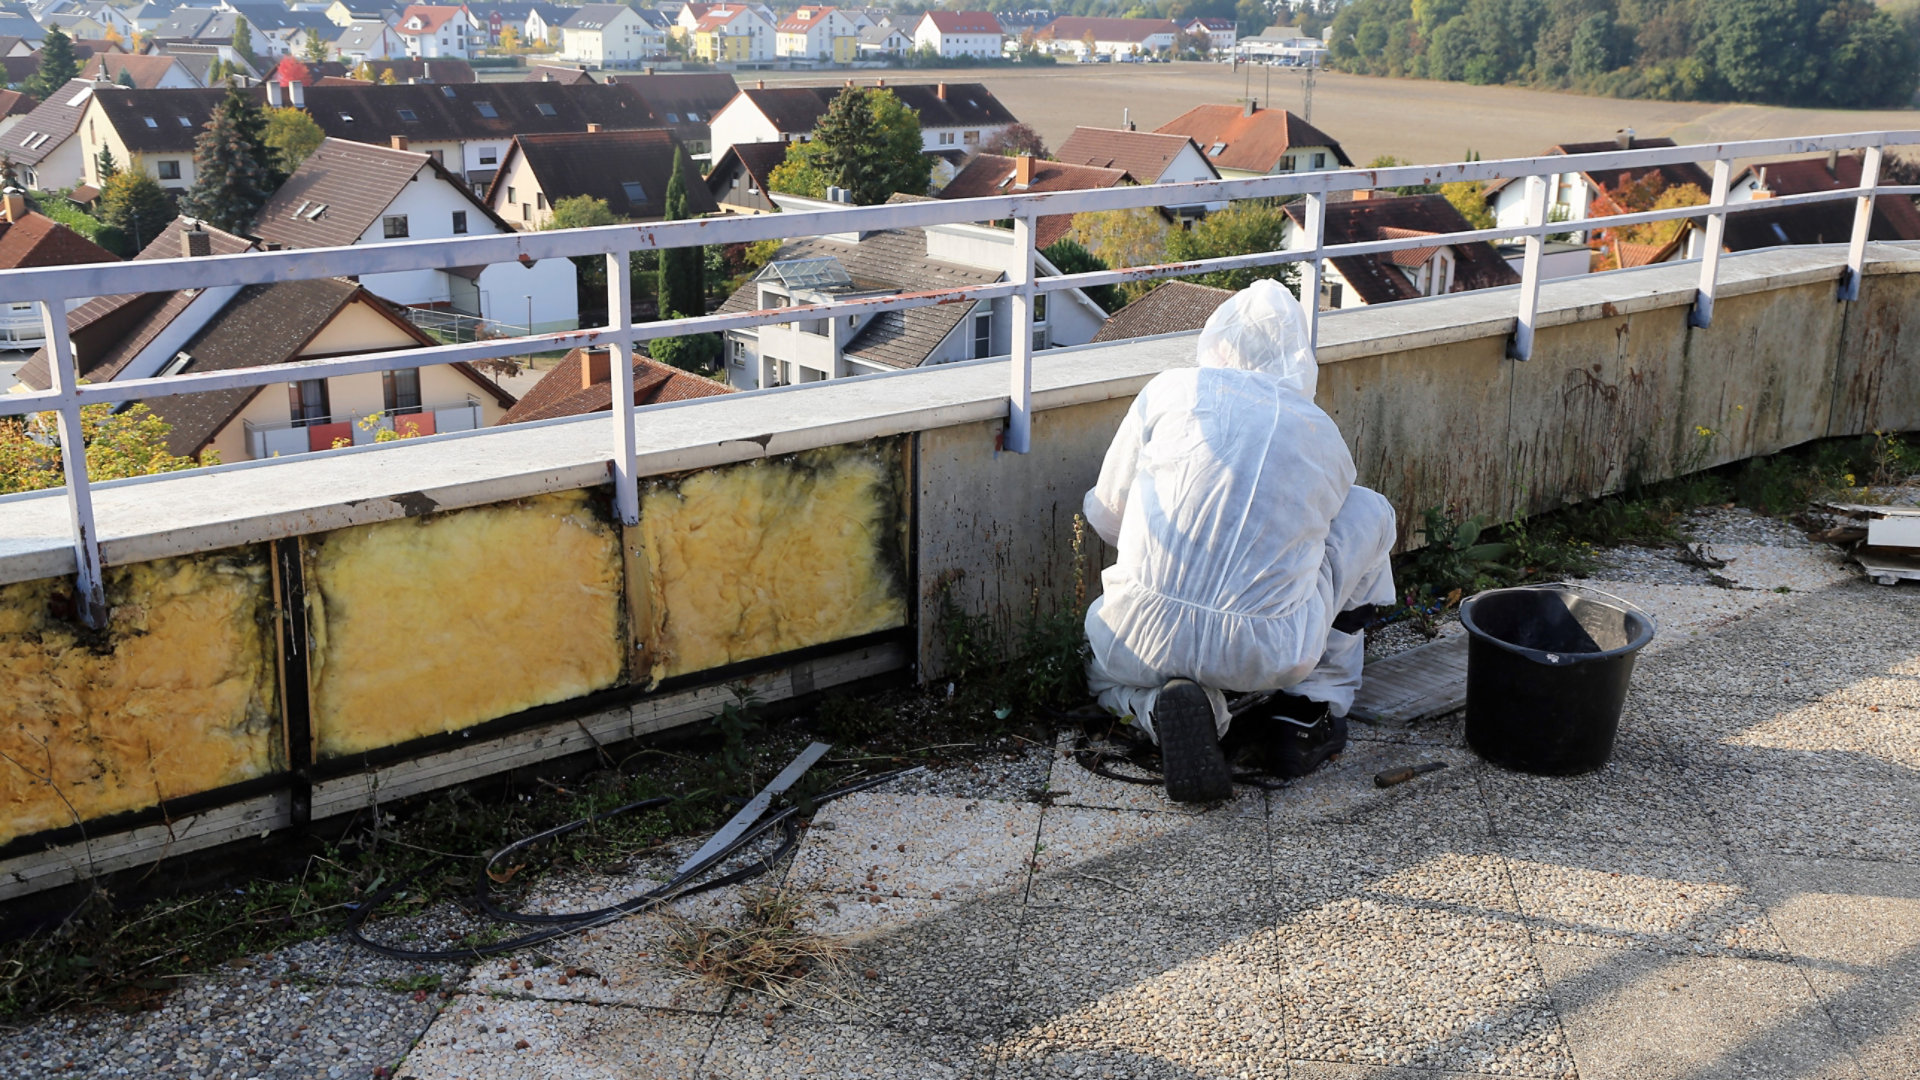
636;432;906;678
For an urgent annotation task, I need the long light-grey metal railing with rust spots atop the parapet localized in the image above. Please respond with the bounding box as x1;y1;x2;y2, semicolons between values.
0;131;1920;625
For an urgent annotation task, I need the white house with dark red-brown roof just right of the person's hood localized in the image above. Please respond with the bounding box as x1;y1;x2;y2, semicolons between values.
1284;192;1521;311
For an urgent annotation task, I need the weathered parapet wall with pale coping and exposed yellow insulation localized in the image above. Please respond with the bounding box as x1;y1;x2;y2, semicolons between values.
0;244;1920;899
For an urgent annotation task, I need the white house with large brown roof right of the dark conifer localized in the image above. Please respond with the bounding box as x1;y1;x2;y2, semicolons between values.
253;138;580;331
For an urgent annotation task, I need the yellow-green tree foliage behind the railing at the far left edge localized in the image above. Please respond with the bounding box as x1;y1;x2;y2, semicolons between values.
0;402;206;494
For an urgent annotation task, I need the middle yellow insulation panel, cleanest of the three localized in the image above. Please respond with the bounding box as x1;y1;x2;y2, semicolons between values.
305;492;626;757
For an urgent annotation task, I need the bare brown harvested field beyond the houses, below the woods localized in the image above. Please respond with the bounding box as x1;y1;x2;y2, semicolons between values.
735;63;1920;163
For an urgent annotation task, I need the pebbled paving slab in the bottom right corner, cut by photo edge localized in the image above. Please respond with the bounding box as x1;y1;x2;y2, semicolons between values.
1749;857;1920;1078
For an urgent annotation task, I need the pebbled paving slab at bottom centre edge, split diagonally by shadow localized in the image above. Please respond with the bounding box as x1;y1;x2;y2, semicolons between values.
998;909;1288;1076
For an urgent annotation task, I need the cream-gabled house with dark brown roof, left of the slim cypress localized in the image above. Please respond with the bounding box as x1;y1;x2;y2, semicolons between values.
486;127;718;231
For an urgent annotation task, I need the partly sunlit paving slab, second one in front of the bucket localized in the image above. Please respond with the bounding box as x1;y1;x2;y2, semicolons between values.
1501;838;1786;959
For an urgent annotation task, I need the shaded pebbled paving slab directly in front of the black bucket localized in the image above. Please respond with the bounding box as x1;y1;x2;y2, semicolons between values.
1480;763;1713;846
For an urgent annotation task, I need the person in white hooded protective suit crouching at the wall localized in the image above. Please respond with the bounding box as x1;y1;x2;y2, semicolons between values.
1085;281;1394;801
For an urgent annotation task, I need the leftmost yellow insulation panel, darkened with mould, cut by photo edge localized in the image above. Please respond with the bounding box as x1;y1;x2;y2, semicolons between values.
0;548;284;844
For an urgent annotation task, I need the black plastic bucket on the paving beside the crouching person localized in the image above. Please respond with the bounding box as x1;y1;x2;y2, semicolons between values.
1459;584;1653;776
